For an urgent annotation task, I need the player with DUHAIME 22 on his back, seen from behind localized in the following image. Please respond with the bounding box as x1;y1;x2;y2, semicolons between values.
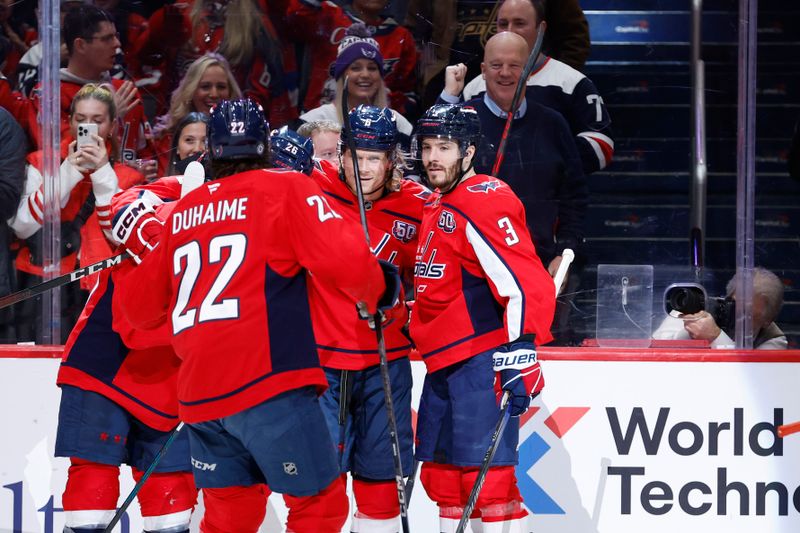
119;100;397;533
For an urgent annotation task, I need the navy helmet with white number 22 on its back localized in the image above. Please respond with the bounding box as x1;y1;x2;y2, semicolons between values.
208;99;269;160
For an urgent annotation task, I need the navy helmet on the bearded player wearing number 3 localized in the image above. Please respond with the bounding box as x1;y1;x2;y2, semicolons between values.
411;104;481;160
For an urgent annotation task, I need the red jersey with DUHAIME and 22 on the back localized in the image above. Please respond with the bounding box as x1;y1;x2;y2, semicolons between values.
118;170;384;422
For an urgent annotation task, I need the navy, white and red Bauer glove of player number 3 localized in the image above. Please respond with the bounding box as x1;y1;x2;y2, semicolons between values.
492;335;544;416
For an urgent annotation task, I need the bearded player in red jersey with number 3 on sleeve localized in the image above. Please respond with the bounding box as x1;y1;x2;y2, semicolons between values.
411;105;555;533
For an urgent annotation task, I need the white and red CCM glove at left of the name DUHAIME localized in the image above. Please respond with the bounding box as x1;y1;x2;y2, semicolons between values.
112;195;164;264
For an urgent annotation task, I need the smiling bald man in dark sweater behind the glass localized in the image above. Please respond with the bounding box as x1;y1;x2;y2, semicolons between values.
442;32;589;316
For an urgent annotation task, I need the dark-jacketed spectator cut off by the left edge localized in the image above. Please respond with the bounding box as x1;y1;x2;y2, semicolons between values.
0;108;26;344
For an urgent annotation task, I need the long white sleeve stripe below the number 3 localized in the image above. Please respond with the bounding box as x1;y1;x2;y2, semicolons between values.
466;222;525;341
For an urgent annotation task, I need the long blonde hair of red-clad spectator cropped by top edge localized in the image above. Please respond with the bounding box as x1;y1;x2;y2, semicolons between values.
190;0;262;65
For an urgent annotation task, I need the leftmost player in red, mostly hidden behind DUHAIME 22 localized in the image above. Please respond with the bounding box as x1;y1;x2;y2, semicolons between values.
55;177;197;533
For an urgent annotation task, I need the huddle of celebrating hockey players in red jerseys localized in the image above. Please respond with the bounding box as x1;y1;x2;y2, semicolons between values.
56;96;555;533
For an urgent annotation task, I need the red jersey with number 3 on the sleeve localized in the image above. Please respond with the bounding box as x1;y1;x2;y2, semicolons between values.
411;174;555;372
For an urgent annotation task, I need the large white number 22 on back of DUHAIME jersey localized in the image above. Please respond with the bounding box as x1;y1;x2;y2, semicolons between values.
172;233;247;335
